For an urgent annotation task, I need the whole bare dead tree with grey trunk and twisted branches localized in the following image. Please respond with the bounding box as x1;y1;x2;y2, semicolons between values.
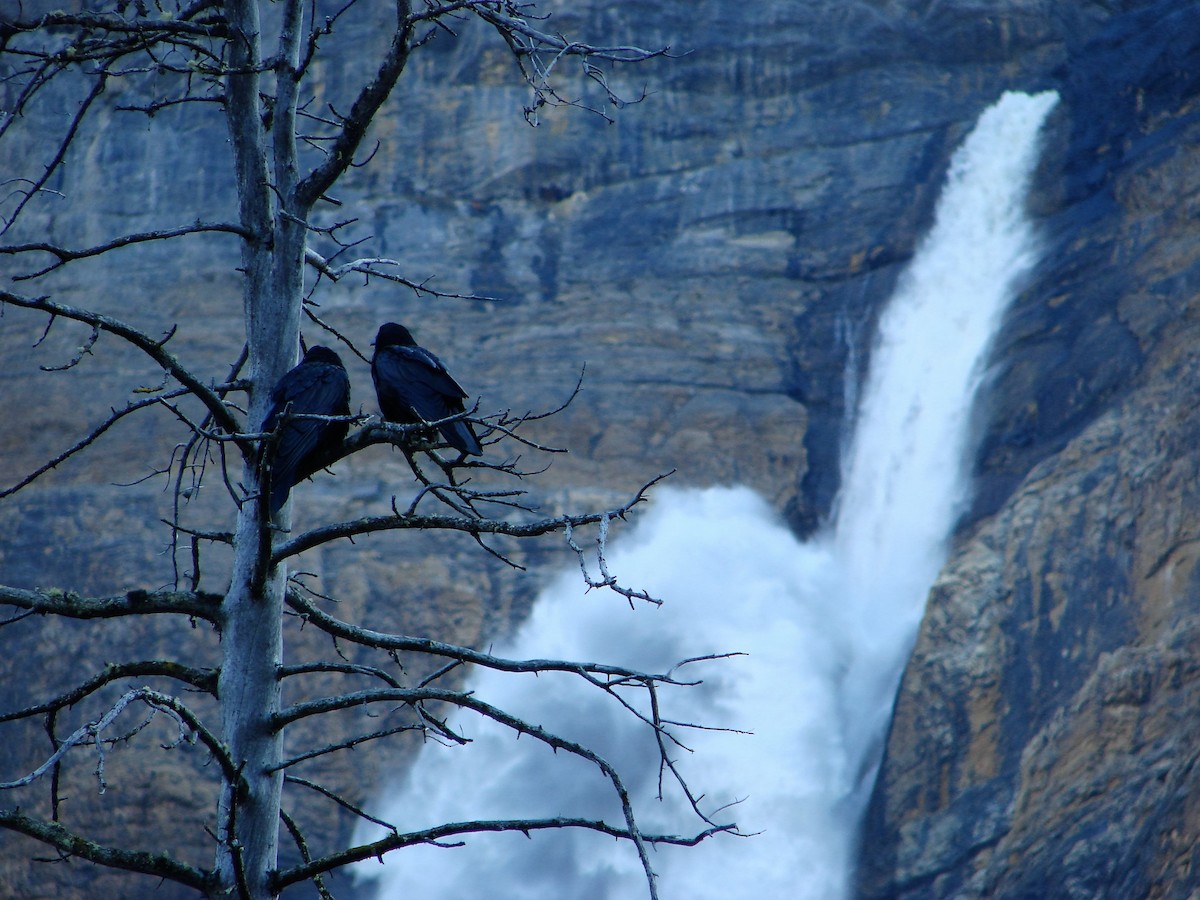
0;0;734;899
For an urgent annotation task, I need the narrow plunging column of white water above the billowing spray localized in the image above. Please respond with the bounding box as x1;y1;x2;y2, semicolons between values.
832;92;1058;806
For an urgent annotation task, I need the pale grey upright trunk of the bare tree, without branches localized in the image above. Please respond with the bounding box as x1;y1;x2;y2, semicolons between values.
217;0;307;900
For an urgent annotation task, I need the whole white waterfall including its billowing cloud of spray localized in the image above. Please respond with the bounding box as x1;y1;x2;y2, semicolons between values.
358;94;1057;900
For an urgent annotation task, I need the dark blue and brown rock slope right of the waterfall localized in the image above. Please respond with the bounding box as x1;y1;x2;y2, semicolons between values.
860;4;1200;898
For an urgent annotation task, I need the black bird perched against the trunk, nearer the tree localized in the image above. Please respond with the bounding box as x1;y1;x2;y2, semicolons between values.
263;346;350;515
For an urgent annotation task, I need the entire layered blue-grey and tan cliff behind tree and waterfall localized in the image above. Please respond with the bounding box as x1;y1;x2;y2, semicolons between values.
0;0;1200;898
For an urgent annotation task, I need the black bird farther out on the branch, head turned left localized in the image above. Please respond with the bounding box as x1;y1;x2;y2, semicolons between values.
371;322;484;456
